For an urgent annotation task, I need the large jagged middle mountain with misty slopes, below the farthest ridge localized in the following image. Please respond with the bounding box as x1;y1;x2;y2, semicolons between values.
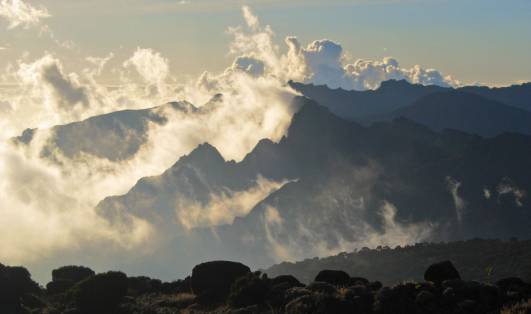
98;97;531;280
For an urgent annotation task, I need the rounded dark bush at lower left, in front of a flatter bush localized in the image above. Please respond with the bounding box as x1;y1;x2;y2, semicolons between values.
70;272;127;313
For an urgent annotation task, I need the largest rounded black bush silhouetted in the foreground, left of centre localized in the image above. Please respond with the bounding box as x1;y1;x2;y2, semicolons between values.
191;261;251;303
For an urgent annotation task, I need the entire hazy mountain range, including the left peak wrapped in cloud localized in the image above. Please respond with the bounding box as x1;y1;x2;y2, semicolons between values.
11;81;531;277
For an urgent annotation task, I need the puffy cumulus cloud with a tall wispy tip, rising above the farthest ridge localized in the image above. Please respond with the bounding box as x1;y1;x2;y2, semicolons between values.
219;6;460;90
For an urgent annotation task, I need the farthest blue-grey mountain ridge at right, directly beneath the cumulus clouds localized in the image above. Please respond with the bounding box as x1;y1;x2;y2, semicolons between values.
290;80;531;137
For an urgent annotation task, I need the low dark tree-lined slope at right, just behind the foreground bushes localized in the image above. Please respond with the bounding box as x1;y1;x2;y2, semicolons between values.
265;239;531;285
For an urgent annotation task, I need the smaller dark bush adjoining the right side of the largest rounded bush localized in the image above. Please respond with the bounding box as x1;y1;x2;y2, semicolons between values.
228;272;271;308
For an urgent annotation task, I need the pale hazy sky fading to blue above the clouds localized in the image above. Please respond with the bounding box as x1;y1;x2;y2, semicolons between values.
0;0;531;85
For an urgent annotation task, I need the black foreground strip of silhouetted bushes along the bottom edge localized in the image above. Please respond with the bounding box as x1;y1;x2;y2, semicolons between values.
0;261;531;314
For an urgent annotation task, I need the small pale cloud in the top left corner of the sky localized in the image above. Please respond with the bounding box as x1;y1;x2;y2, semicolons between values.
0;0;50;29
